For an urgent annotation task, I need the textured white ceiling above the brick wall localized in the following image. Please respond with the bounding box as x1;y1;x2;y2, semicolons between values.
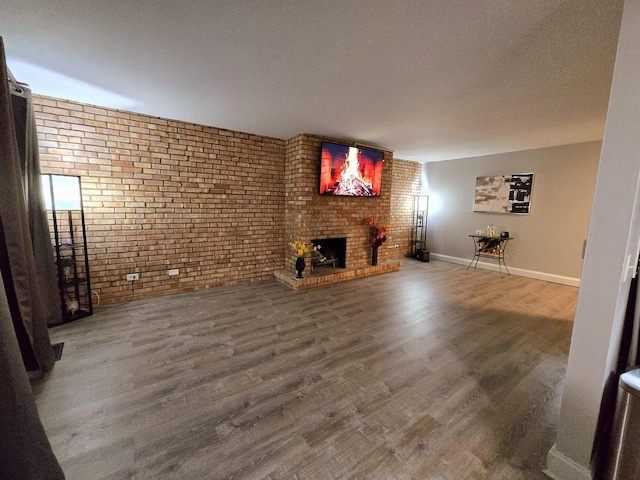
0;0;623;162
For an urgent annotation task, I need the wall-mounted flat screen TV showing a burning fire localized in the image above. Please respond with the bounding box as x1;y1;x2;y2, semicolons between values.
320;142;384;197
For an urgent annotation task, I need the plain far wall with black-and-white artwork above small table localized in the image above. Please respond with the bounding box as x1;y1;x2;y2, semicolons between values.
423;142;601;282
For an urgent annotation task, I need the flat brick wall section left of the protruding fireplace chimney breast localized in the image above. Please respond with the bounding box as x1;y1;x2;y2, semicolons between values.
34;96;285;303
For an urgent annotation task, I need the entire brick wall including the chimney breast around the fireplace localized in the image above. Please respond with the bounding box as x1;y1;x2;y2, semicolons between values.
34;96;420;304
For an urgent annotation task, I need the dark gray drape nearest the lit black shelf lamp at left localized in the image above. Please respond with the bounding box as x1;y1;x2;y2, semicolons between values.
0;38;61;376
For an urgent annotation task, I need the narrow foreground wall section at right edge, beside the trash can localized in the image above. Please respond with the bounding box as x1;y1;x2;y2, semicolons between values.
547;0;640;480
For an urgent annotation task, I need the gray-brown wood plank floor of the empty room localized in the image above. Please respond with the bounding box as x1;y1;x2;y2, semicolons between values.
34;259;578;480
